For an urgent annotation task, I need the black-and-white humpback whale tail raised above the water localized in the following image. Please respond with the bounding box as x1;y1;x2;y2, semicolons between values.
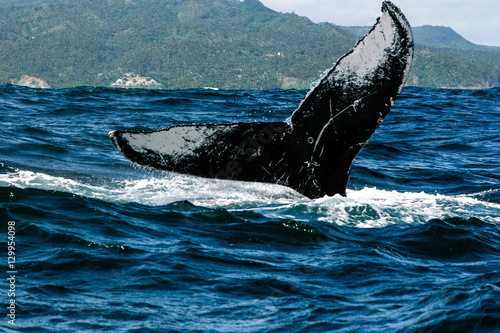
109;1;413;198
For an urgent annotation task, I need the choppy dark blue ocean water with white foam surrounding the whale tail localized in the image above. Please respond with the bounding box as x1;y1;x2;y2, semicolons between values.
0;85;500;332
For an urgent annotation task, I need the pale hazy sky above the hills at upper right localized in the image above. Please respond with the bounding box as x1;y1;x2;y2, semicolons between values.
261;0;500;46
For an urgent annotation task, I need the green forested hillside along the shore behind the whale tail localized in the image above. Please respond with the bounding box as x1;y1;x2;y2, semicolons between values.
0;0;500;89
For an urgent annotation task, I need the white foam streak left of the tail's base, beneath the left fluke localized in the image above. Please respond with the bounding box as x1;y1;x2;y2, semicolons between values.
0;170;303;208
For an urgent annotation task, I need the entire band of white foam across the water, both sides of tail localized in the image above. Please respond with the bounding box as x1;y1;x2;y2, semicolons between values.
0;170;500;228
